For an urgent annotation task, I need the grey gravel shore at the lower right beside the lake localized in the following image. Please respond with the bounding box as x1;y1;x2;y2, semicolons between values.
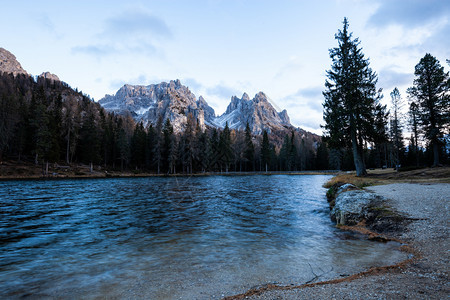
239;183;450;299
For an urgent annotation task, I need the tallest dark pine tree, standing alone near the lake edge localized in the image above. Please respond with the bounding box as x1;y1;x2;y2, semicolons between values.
323;18;381;176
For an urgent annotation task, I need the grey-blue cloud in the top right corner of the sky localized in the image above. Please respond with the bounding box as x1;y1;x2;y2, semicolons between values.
369;0;450;27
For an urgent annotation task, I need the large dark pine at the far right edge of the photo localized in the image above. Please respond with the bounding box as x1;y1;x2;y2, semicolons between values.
408;53;450;166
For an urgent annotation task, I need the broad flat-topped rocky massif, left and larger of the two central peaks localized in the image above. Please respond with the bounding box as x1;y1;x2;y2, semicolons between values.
99;80;215;132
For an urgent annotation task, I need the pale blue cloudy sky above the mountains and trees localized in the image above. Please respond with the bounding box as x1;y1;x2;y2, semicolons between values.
0;0;450;134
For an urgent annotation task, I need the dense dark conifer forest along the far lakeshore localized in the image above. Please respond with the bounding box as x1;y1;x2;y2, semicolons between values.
0;73;329;174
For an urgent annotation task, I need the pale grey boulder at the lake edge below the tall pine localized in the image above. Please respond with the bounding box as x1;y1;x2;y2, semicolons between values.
330;190;383;225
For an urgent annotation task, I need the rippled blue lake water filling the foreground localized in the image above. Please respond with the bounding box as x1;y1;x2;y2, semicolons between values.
0;175;405;299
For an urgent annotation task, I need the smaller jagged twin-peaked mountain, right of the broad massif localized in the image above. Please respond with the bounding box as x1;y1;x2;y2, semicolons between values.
213;92;292;134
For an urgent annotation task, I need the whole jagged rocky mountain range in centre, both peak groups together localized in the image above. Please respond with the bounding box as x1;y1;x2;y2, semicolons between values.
99;80;292;134
